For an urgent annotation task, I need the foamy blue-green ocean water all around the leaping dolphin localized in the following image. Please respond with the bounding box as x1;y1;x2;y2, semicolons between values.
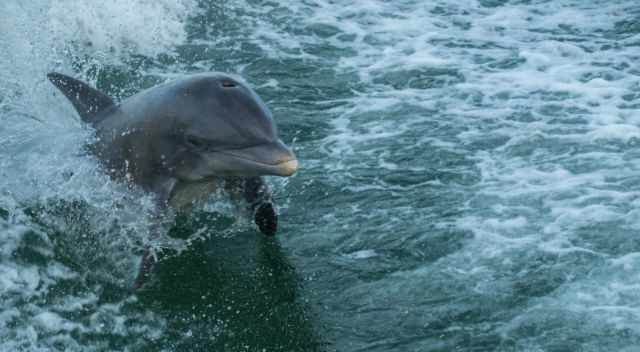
0;0;640;351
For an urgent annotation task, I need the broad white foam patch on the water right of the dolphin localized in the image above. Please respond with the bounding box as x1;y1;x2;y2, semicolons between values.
232;1;640;349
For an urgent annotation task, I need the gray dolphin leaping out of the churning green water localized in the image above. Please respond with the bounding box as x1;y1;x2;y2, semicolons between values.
47;72;298;289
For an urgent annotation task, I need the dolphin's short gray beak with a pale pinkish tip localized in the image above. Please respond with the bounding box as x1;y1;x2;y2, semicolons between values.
223;139;298;176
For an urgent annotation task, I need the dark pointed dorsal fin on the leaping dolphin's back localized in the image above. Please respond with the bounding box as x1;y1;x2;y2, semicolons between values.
47;72;115;123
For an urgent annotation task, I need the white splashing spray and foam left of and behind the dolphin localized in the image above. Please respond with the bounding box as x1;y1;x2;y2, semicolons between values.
0;0;192;351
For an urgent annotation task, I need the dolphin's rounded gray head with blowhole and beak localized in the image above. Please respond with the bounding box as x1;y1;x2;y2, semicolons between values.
162;73;298;182
